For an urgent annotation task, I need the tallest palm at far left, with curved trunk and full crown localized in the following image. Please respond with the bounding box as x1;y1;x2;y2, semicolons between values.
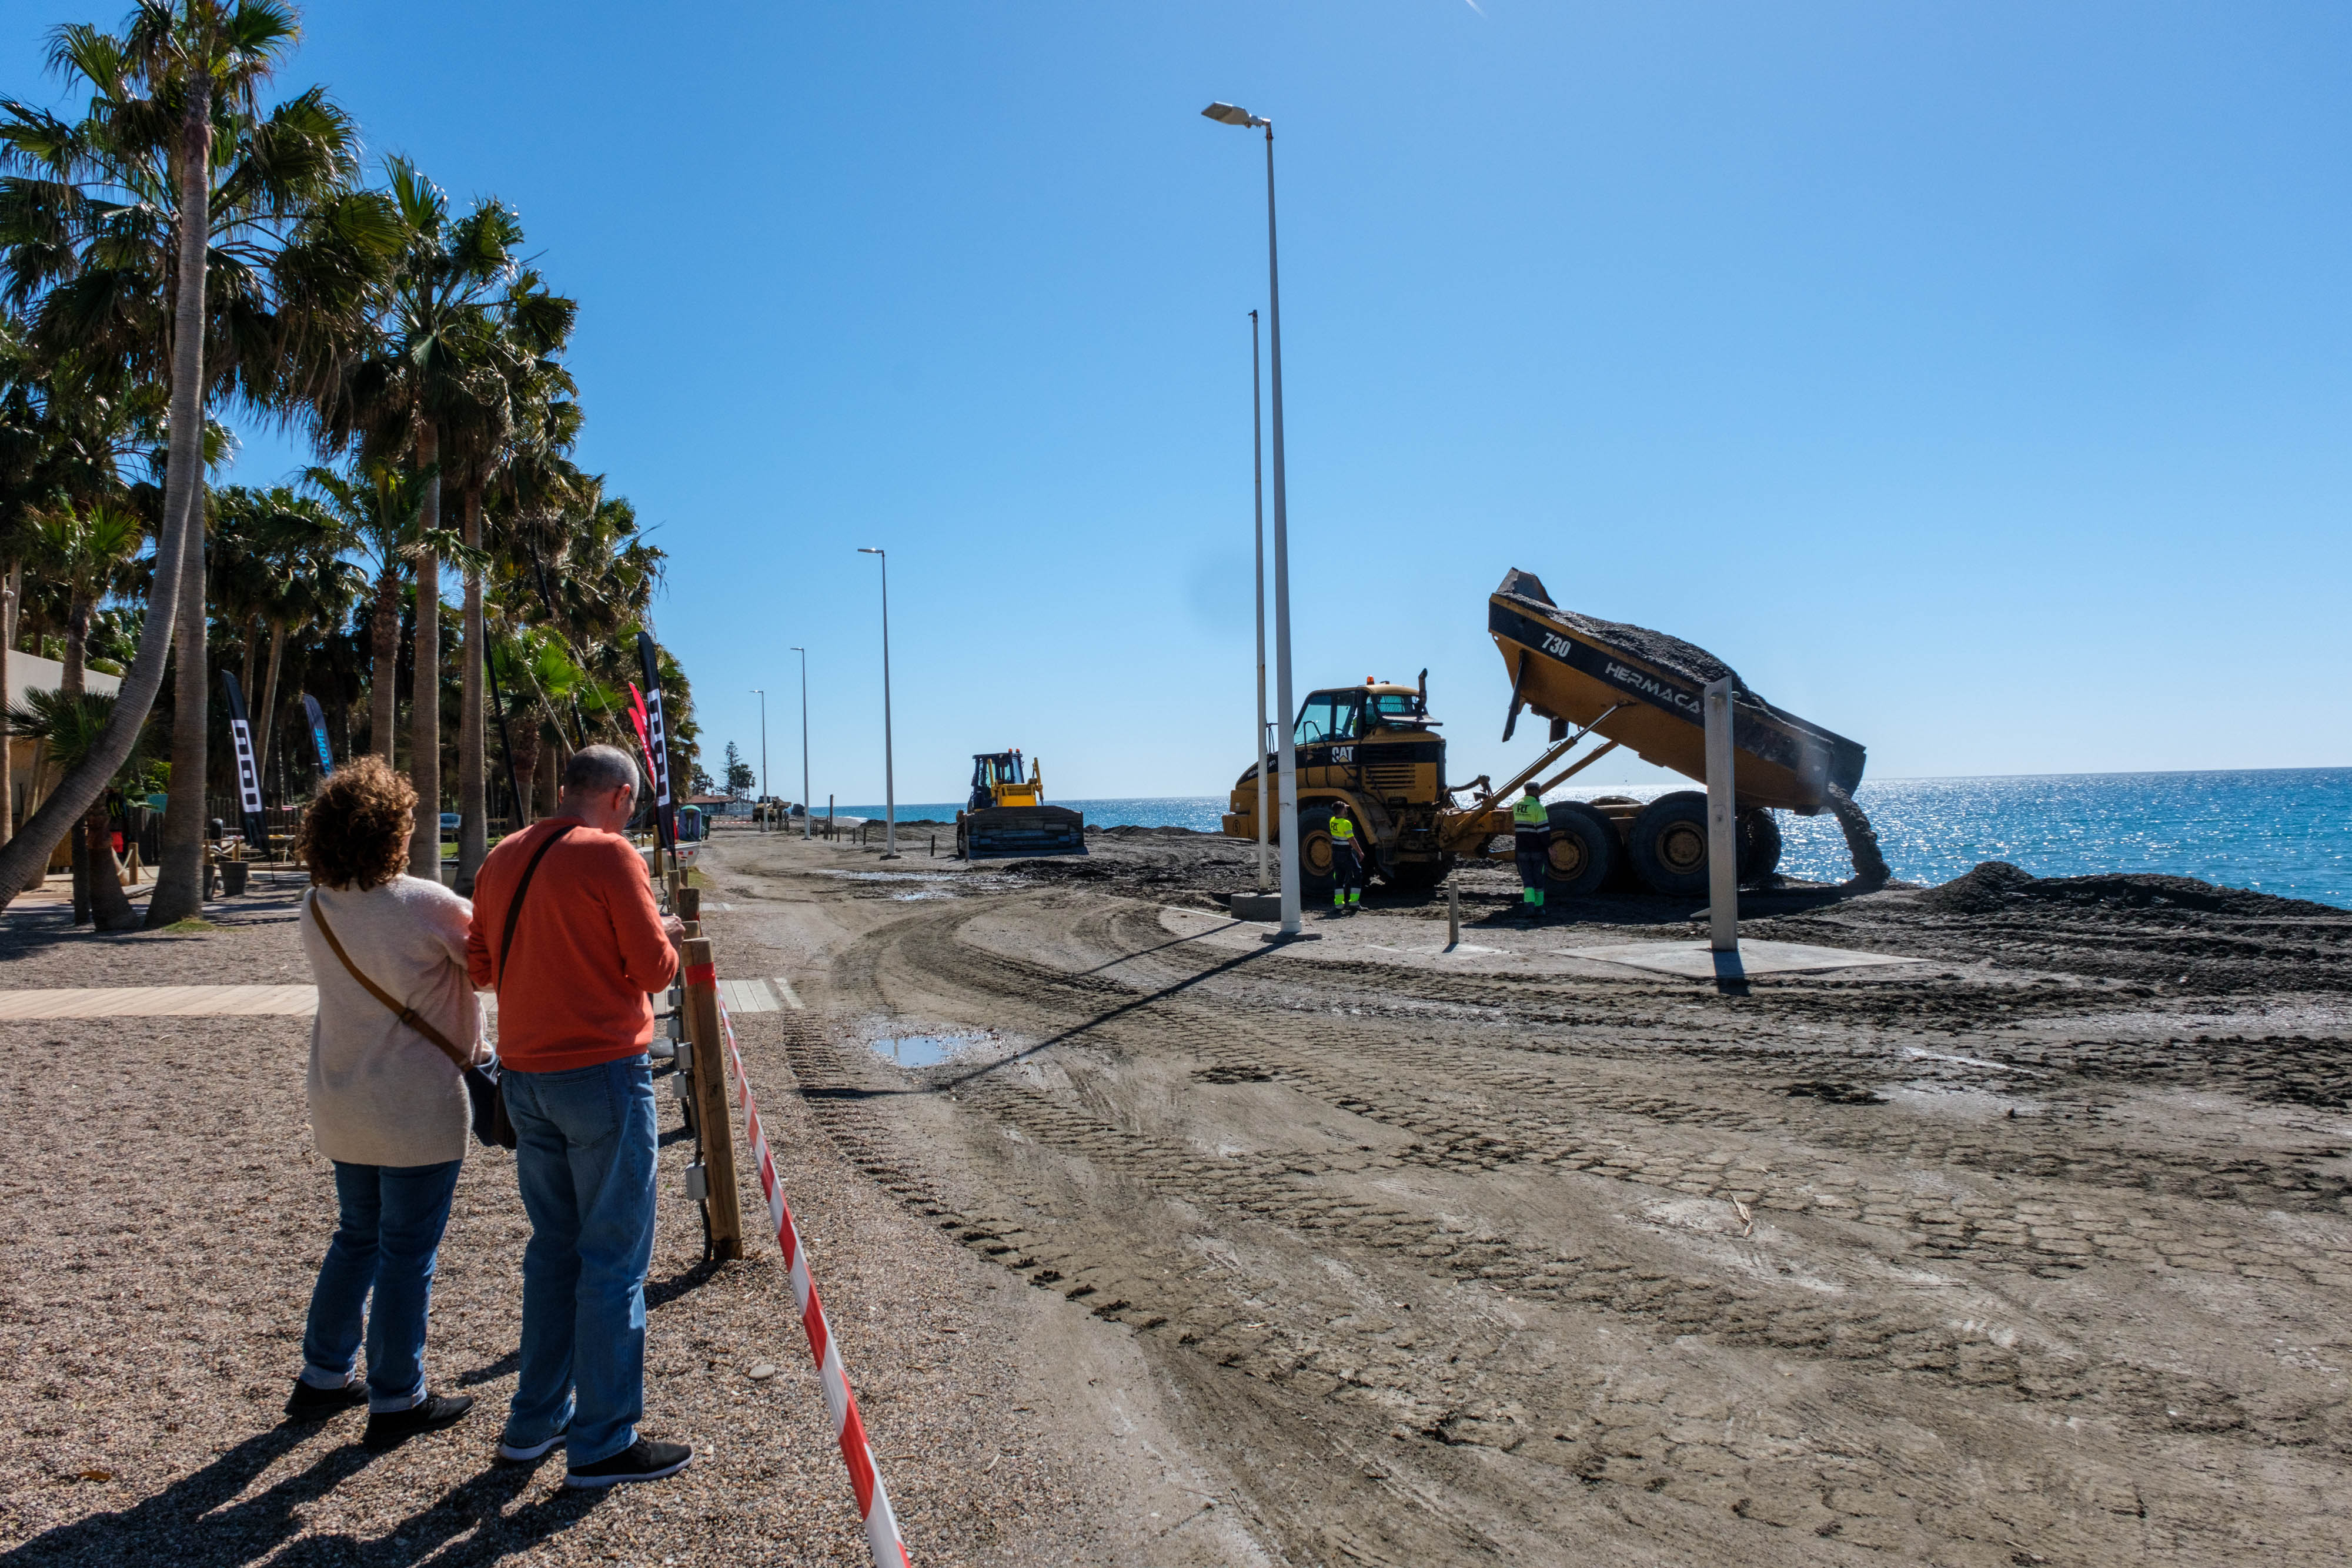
0;0;383;924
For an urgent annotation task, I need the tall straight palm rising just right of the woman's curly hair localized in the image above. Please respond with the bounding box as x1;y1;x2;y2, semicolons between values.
320;158;522;877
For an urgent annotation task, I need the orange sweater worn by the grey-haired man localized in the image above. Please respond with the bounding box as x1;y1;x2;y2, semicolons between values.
466;815;677;1072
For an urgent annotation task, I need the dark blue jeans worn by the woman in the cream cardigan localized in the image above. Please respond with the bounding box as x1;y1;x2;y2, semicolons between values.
301;1159;463;1410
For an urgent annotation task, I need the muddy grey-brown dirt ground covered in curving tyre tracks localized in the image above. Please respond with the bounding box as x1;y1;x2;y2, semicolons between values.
703;834;2352;1568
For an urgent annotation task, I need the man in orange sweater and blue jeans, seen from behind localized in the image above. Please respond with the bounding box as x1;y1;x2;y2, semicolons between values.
466;745;694;1486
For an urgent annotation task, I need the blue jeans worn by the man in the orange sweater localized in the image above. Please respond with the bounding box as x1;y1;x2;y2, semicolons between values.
501;1053;656;1467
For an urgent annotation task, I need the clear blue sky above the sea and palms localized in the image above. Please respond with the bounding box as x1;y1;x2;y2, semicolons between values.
18;0;2352;801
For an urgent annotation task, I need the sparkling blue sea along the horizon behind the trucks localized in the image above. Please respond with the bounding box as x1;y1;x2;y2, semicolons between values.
840;769;2352;907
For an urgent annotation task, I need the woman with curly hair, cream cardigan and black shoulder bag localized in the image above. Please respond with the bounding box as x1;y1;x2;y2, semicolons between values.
287;757;487;1448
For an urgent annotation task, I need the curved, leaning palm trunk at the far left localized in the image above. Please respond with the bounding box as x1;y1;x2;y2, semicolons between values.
0;73;212;919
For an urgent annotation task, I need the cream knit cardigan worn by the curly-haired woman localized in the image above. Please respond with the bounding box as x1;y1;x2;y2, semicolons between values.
301;877;482;1166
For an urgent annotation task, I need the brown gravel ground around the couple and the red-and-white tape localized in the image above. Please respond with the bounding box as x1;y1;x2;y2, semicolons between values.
0;891;1143;1568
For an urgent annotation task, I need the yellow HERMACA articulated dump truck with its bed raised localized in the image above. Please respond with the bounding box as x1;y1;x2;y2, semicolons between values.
1223;569;1886;895
